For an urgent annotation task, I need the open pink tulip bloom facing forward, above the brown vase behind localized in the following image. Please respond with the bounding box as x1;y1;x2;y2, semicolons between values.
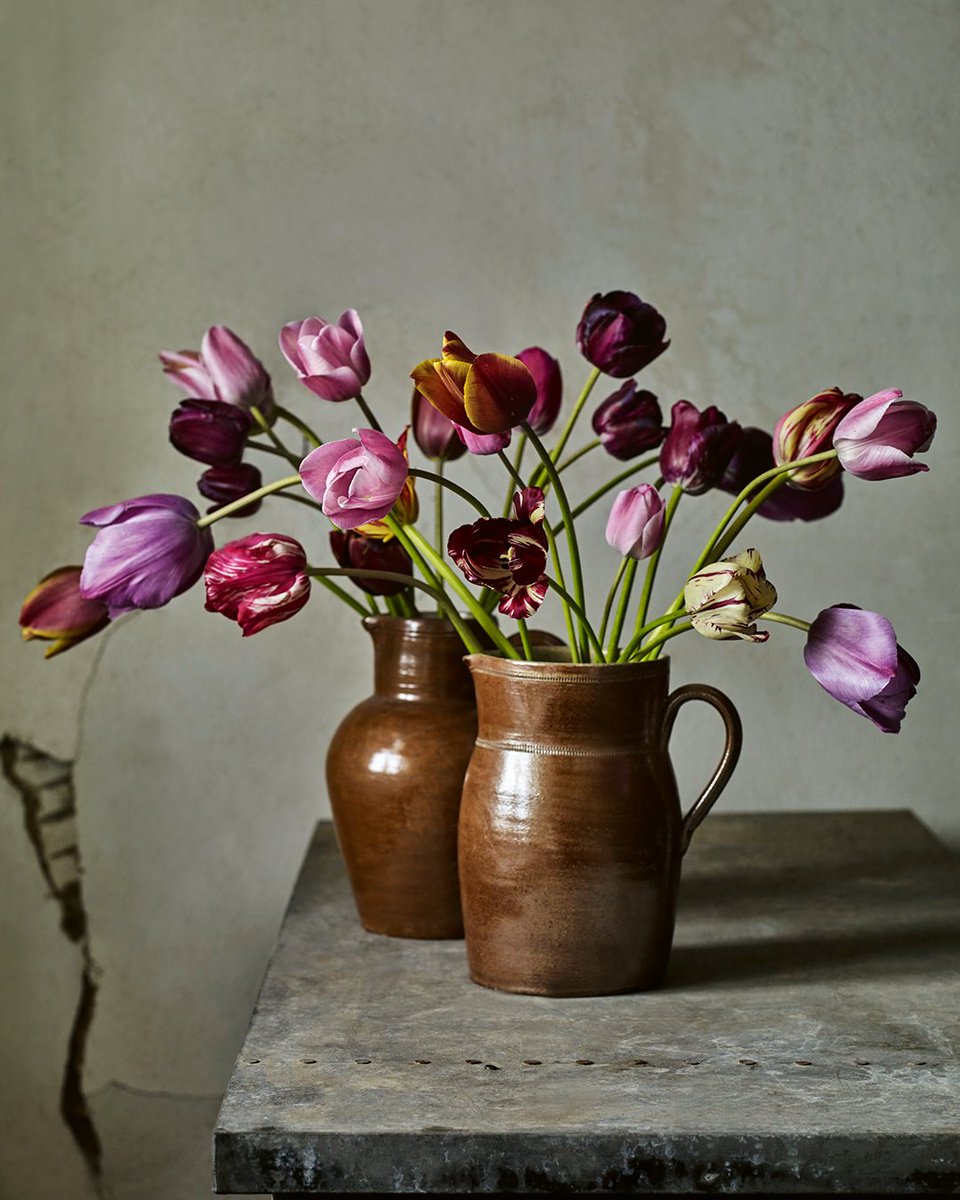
300;430;409;529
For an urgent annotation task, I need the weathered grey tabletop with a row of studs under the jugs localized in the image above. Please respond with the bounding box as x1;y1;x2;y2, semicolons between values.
215;811;960;1194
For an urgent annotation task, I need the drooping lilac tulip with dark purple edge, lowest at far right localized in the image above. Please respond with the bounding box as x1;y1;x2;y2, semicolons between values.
803;604;920;733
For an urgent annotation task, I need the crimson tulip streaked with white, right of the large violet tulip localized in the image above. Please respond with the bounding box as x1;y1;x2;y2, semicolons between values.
204;533;310;637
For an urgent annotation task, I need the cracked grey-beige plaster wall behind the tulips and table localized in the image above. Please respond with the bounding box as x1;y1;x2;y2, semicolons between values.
0;0;960;1196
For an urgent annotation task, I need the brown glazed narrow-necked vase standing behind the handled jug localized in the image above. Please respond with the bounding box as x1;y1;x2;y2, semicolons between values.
326;617;476;937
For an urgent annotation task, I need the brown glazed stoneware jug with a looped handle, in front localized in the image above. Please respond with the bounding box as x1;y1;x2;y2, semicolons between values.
460;654;740;996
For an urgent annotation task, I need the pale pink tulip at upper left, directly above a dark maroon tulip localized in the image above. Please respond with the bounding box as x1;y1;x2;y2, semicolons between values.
160;325;274;419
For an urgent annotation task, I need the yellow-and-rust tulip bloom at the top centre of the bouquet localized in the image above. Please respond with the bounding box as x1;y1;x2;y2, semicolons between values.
410;331;536;433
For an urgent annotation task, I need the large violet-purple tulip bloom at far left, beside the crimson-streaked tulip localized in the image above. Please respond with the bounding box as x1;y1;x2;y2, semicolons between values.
80;494;214;618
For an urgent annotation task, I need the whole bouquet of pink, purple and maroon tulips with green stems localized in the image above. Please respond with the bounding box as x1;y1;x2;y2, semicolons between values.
20;292;936;732
